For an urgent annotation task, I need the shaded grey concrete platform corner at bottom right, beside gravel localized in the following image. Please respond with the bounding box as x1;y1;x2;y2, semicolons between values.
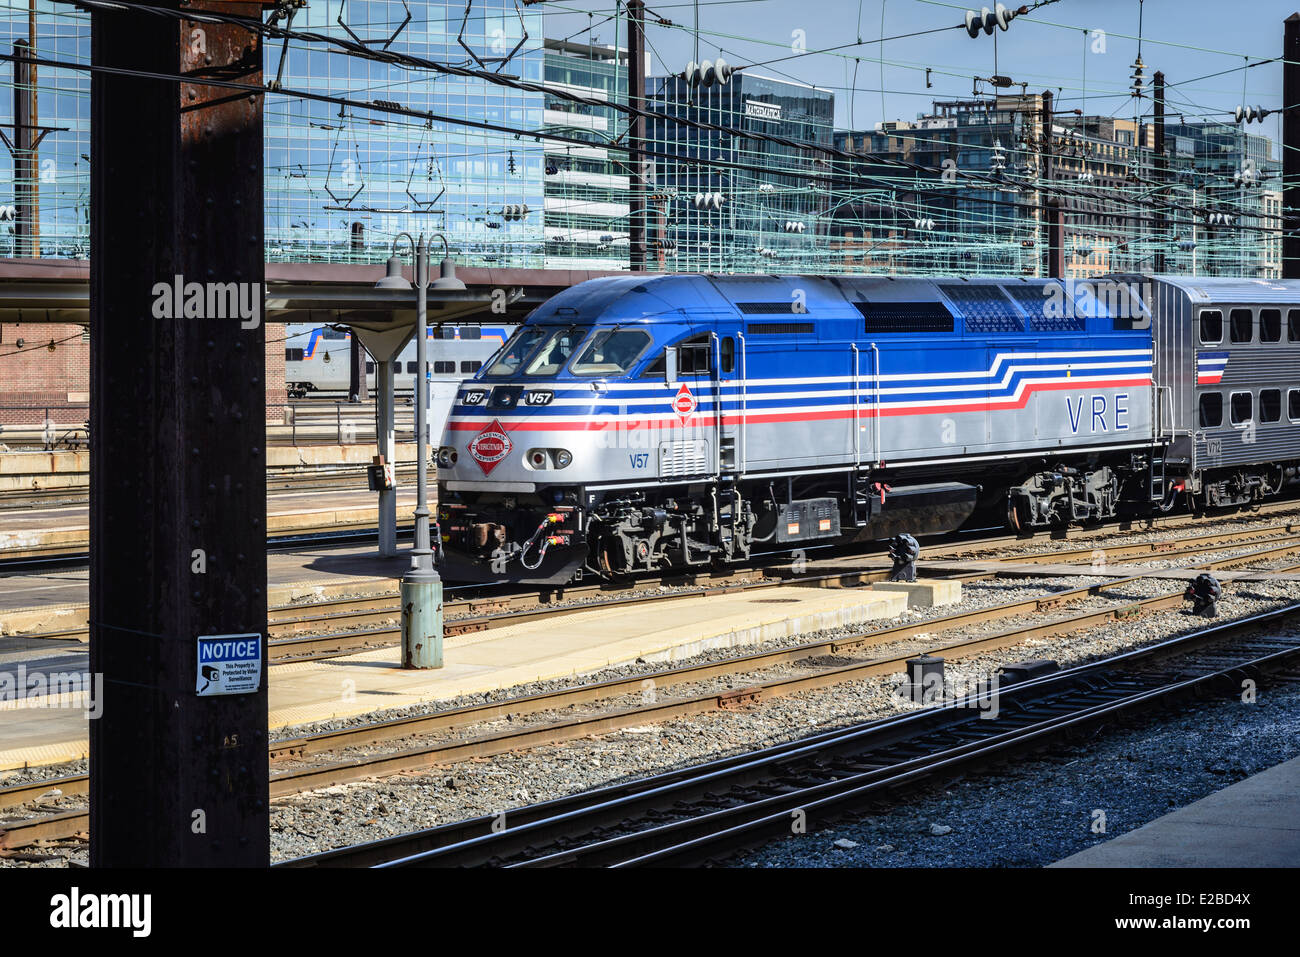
1050;758;1300;867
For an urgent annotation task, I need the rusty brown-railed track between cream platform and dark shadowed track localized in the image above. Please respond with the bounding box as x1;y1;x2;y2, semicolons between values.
10;541;1300;849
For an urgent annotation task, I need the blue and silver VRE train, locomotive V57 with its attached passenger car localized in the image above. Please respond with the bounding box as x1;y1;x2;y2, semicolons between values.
438;276;1300;584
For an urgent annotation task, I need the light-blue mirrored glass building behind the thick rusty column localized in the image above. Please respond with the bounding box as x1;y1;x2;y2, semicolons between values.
0;0;545;268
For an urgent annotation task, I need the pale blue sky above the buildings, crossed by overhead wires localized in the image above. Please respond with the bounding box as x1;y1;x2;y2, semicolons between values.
543;0;1300;155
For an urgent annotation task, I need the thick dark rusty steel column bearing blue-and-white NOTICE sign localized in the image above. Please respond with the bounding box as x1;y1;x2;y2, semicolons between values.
90;0;269;867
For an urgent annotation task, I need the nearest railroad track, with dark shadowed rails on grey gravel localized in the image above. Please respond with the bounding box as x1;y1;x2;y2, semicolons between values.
289;605;1300;867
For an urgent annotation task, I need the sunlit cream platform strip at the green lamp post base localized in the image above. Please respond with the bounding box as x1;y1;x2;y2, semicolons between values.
0;583;959;770
